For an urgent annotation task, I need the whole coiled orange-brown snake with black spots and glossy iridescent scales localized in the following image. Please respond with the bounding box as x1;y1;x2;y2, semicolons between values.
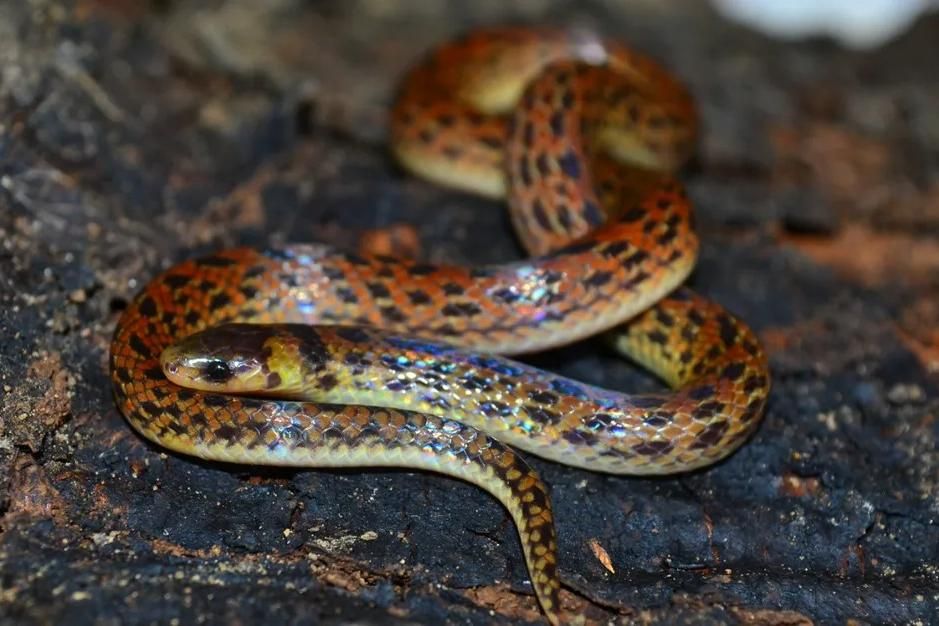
110;27;770;624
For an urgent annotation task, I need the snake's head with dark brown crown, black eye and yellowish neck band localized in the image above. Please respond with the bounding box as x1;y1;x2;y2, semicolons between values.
160;324;292;395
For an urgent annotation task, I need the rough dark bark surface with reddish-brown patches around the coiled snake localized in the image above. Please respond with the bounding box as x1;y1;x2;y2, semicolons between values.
0;0;939;624
